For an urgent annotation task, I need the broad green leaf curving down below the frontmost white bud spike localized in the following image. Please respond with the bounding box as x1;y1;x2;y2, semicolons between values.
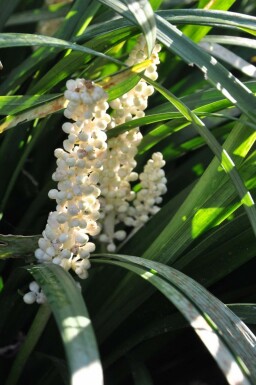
28;264;103;385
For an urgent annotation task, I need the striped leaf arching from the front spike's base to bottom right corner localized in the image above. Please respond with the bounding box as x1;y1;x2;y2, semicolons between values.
92;255;256;385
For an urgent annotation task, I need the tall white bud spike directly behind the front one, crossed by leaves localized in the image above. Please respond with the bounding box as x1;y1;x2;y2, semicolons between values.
99;36;163;252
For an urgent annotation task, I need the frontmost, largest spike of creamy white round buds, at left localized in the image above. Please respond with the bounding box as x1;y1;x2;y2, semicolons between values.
22;79;110;302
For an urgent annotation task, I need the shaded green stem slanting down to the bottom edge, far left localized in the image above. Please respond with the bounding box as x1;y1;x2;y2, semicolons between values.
5;304;51;385
